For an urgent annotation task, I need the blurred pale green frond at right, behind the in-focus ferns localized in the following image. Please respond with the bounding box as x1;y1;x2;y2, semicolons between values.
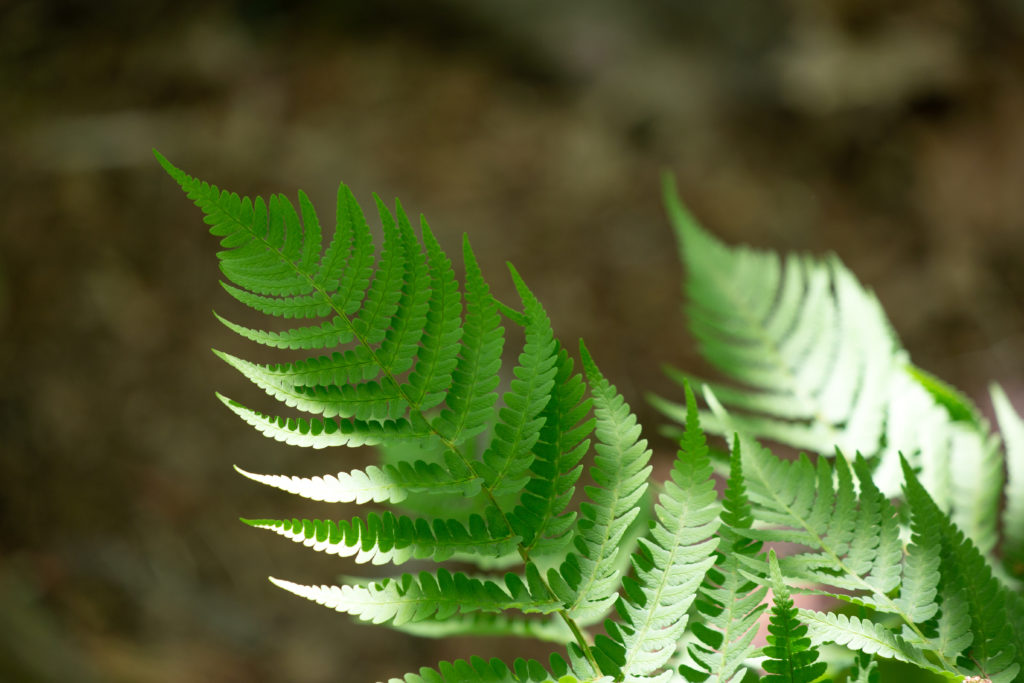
654;179;1024;575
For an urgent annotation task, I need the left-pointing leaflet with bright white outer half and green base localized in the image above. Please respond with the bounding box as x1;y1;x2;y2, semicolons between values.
234;461;483;504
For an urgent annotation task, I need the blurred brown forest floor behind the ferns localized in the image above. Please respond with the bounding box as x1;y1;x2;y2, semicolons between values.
6;0;1024;683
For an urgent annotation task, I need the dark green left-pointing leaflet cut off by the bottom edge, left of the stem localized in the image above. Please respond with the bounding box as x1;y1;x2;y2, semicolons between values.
388;656;612;683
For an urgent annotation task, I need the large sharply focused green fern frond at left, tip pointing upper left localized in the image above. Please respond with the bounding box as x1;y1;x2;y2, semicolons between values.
158;155;718;681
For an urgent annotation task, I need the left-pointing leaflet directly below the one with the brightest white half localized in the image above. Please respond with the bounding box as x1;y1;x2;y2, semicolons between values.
243;511;519;564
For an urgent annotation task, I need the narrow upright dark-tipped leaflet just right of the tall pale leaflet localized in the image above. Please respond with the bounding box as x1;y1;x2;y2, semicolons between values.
680;438;768;683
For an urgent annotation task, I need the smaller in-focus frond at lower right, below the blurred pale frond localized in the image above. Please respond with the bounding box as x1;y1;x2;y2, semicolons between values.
708;394;1024;683
